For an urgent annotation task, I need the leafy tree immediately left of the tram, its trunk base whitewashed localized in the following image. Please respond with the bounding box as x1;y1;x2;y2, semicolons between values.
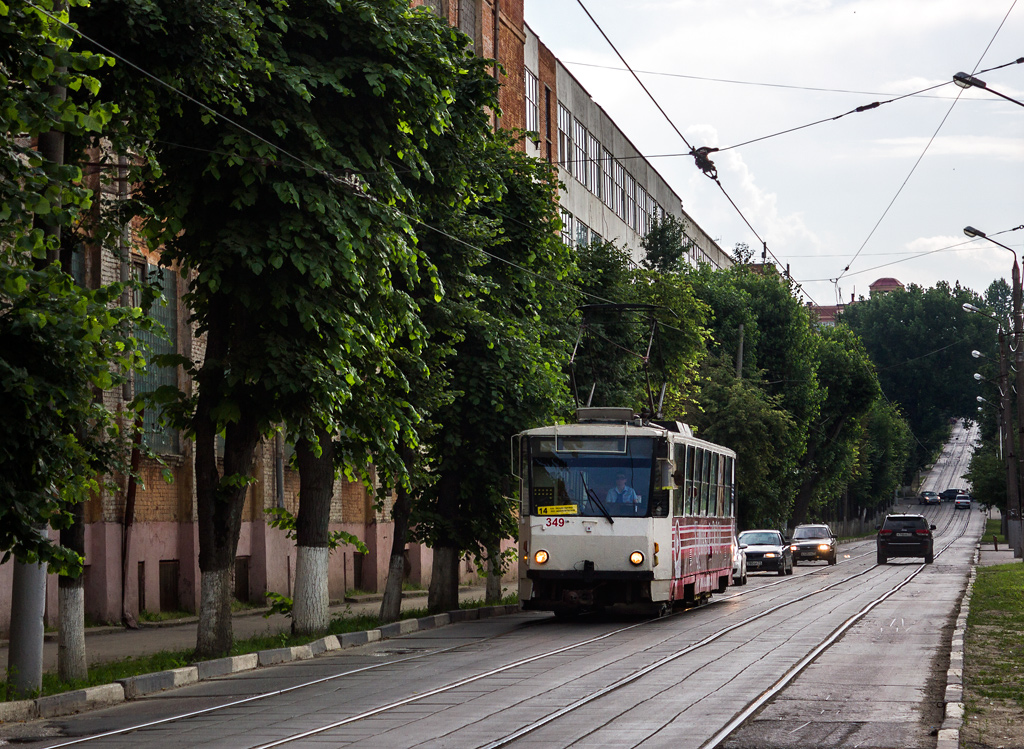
413;133;577;611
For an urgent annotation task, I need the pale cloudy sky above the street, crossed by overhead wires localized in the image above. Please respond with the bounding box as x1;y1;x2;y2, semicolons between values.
525;0;1024;304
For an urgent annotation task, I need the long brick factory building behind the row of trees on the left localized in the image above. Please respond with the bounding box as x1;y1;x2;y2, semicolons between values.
0;0;728;632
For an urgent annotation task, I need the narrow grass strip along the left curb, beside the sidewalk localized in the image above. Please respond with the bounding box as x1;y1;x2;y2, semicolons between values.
0;593;519;702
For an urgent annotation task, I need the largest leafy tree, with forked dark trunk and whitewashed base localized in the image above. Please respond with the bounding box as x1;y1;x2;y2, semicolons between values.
80;0;507;655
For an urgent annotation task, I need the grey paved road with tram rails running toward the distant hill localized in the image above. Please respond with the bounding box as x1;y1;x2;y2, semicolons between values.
6;503;984;749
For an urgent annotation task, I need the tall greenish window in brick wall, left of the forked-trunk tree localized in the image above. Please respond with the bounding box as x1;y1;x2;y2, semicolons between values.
135;264;179;455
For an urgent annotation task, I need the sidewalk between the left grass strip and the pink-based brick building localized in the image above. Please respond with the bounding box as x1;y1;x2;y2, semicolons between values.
0;584;514;677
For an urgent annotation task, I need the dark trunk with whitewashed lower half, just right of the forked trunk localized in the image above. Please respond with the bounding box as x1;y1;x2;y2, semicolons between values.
292;427;335;634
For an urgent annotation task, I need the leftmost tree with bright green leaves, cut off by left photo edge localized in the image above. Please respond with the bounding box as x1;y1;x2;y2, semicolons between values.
0;0;153;693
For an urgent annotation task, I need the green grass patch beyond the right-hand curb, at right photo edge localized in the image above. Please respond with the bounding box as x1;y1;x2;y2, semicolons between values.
964;563;1024;715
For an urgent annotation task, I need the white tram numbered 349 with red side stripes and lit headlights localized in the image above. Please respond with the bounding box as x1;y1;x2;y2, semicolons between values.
516;408;736;615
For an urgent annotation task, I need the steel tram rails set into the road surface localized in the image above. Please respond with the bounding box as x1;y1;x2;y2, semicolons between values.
41;512;970;749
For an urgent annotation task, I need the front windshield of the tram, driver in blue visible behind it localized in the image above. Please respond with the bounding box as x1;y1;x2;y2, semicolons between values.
530;434;654;517
